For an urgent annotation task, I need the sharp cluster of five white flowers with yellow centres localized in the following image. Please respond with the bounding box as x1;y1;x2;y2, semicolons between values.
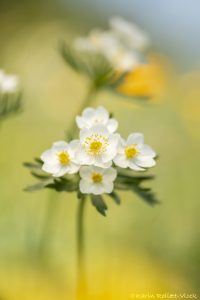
41;107;156;195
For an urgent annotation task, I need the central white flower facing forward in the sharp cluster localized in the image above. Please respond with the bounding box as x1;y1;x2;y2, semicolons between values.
76;125;119;168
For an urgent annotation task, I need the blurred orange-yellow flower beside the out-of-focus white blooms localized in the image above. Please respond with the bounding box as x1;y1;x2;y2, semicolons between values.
117;58;167;98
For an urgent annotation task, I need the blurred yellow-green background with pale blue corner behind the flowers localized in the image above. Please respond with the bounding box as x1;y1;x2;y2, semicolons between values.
0;0;200;300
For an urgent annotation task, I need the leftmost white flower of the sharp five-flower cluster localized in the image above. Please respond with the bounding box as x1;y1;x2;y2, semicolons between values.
41;140;80;177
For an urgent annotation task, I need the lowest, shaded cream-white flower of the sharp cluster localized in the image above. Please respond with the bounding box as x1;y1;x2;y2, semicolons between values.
80;166;117;195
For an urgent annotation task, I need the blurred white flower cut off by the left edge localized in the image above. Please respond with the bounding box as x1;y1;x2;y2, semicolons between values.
0;70;19;93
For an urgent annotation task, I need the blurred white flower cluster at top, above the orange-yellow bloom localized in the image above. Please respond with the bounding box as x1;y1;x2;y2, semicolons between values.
74;17;150;73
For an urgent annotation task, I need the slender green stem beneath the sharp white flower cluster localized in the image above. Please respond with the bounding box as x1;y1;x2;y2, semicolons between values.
77;197;87;300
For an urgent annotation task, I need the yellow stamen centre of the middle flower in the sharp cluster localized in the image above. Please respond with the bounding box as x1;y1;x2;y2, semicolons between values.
84;134;108;155
